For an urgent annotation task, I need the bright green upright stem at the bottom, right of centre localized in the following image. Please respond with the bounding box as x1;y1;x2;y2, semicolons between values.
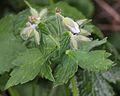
71;76;79;96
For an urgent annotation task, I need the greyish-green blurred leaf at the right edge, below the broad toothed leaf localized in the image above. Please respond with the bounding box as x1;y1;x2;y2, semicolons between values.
102;66;120;83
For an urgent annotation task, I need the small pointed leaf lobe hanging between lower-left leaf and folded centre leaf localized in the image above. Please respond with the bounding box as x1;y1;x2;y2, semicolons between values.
40;64;55;81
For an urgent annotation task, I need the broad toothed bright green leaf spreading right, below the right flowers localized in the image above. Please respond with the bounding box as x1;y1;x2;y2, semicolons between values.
66;50;113;71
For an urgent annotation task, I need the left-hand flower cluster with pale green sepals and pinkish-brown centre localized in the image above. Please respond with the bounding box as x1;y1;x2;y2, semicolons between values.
20;7;47;45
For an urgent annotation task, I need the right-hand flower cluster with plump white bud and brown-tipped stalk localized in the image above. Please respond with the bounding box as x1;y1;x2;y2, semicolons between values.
56;8;91;49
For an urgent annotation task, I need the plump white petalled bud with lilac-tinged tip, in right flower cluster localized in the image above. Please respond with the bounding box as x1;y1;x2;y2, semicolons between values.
63;17;80;33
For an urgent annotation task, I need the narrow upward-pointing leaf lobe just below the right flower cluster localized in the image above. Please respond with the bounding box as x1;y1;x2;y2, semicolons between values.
80;38;107;51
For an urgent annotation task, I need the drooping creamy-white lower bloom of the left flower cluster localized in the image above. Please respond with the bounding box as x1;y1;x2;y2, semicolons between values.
20;22;40;45
